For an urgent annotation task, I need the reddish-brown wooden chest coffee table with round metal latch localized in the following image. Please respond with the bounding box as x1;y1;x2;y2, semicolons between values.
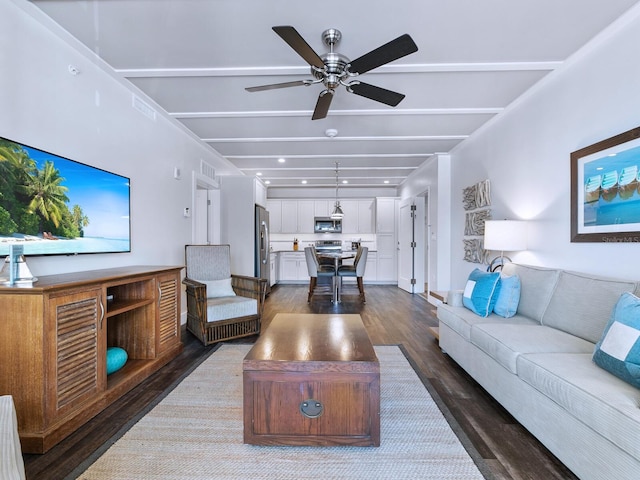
243;313;380;446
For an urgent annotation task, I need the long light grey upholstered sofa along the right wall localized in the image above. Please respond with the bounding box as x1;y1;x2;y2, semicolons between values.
438;263;640;480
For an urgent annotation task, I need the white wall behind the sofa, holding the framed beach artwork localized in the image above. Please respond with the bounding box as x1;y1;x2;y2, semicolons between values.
407;7;640;288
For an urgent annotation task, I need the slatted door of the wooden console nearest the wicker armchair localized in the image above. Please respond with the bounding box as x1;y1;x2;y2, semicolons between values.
157;274;180;353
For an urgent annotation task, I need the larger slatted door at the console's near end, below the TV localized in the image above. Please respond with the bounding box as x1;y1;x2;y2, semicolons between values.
47;289;106;419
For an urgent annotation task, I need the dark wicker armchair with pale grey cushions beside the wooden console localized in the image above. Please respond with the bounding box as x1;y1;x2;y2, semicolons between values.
182;245;267;345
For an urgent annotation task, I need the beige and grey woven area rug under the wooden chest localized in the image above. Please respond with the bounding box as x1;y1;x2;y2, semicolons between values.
72;344;484;480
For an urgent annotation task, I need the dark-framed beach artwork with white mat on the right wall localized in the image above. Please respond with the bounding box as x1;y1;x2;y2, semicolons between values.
571;127;640;242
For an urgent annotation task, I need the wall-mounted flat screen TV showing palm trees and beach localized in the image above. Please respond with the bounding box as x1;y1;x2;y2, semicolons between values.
0;137;131;255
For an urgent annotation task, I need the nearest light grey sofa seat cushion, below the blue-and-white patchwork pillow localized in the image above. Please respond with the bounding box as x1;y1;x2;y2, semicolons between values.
517;353;640;458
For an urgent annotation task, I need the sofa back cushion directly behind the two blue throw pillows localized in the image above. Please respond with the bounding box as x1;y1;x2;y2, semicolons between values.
502;263;556;322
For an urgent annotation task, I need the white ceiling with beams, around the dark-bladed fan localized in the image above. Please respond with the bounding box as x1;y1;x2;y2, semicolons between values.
32;0;638;191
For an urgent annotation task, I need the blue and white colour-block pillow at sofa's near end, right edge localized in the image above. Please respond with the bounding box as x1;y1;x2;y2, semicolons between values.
593;293;640;388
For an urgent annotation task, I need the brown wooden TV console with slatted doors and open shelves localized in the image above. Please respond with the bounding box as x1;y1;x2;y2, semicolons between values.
0;266;183;453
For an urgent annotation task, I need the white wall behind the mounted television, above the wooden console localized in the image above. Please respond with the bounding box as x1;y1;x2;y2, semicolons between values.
0;0;239;276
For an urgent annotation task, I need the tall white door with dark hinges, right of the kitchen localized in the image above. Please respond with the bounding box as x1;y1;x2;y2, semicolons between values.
398;197;425;293
